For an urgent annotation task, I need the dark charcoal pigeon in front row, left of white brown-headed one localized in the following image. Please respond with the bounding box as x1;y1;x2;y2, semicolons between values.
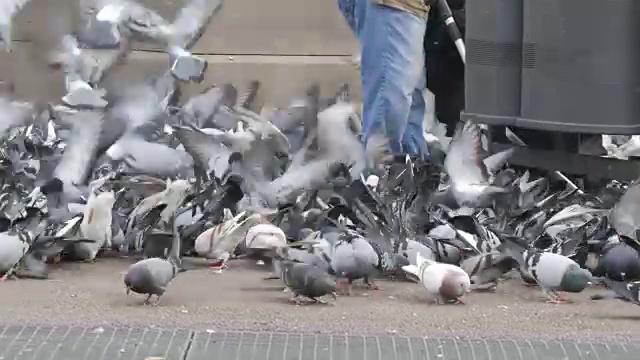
275;248;336;305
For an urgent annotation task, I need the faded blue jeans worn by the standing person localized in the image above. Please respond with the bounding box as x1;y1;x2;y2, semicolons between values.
338;0;428;156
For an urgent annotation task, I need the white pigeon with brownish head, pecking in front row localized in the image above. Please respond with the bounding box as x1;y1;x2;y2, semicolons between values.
402;253;471;304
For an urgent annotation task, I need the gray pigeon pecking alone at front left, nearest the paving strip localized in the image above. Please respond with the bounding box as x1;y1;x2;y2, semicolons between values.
124;213;181;305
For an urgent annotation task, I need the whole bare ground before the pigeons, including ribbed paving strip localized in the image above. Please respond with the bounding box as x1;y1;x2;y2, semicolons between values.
0;259;640;360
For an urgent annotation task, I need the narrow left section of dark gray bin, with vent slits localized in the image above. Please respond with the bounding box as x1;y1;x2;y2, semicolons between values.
463;0;523;125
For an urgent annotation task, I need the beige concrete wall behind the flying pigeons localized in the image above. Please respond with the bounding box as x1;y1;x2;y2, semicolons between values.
0;0;359;104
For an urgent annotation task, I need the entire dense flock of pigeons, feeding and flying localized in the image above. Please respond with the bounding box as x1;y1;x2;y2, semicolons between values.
0;0;640;310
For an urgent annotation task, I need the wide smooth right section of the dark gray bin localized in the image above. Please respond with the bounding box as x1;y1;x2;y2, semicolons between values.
520;0;640;134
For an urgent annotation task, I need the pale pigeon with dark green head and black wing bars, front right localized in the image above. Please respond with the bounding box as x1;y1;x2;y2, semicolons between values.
500;236;592;304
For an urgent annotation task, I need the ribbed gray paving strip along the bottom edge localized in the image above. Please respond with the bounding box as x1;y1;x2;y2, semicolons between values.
0;326;640;360
